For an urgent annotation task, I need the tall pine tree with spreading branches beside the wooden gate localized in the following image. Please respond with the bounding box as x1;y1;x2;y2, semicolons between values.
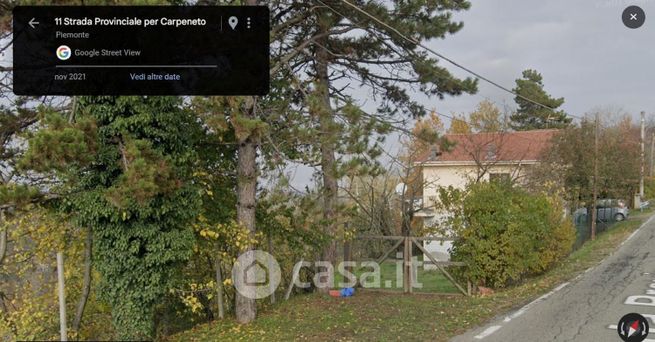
291;0;477;283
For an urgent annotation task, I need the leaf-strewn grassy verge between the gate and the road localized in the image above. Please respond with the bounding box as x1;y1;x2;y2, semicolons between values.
168;208;651;341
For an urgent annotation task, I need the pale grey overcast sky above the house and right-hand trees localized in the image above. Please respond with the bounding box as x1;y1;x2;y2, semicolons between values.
424;0;655;120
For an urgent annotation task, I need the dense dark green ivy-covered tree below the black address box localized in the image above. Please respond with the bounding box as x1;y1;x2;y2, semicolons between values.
20;97;201;338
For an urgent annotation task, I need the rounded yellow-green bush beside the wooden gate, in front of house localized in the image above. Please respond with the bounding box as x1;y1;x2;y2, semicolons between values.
448;182;575;288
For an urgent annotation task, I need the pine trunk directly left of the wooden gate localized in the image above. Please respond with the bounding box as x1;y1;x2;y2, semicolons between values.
316;18;338;292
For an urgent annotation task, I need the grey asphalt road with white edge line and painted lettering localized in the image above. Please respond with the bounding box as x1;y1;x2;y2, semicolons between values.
452;216;655;342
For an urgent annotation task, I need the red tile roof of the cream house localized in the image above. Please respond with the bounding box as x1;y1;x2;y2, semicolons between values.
420;129;558;162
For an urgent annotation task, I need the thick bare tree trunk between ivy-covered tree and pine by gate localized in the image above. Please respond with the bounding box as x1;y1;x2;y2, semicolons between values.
235;97;258;323
